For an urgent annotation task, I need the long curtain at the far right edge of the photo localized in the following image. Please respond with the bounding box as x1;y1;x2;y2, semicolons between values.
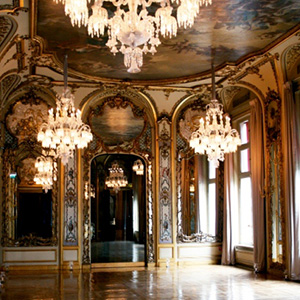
282;82;300;280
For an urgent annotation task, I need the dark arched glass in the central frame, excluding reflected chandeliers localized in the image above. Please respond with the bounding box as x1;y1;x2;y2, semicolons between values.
91;154;146;263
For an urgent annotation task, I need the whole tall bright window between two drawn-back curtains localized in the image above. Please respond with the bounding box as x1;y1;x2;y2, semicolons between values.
238;119;253;246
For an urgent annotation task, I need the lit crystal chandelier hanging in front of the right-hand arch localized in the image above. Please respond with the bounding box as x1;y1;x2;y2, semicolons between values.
190;66;241;168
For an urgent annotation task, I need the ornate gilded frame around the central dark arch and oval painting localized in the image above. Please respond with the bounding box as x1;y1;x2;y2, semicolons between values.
82;95;155;264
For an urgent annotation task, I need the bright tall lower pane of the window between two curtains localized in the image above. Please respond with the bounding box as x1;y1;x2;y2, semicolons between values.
240;177;253;245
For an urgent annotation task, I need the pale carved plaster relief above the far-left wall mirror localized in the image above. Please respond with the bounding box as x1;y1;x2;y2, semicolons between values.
7;102;48;143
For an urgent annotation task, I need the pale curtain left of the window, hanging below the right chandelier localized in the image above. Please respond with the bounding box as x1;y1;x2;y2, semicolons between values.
221;153;238;265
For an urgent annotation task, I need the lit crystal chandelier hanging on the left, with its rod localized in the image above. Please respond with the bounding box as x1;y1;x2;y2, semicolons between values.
37;56;93;165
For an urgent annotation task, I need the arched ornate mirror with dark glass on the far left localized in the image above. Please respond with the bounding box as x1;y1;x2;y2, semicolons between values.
1;92;57;247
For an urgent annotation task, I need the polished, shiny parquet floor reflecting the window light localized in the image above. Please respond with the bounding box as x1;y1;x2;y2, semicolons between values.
0;266;300;300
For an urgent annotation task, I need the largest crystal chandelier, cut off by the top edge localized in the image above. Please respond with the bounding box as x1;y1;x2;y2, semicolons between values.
53;0;212;73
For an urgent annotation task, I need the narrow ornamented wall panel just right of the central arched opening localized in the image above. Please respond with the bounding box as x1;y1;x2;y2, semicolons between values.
158;118;172;243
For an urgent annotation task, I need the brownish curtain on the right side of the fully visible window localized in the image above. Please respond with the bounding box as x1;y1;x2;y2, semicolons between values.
250;99;266;272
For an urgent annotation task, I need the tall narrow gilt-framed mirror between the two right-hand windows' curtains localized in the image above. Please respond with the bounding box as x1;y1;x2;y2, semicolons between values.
265;90;286;271
